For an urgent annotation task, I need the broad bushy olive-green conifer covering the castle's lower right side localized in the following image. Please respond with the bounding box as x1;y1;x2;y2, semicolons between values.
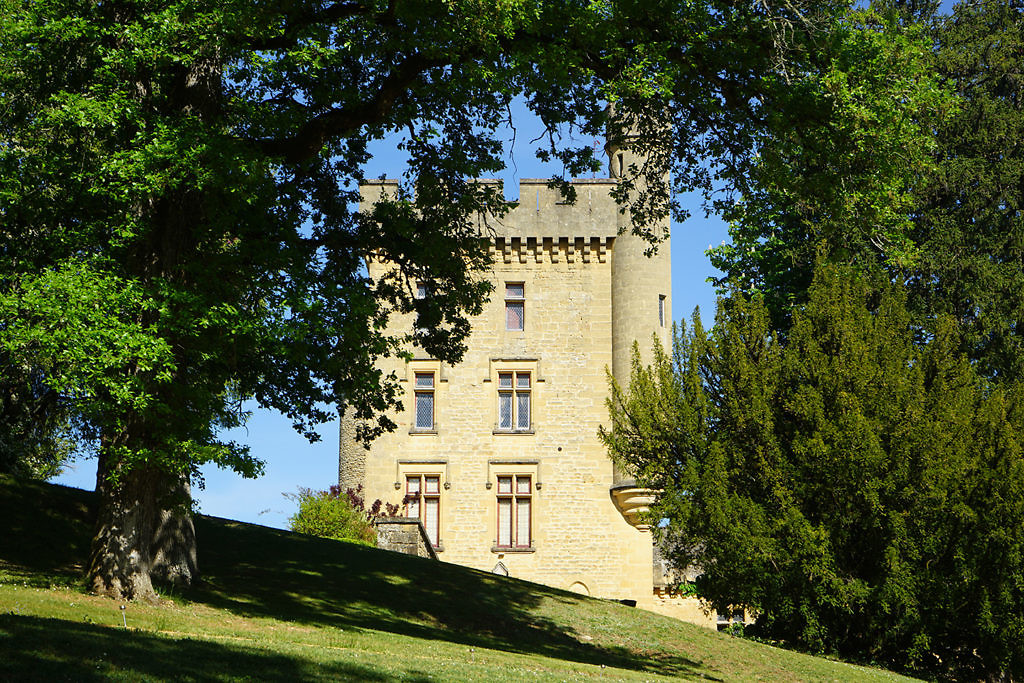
603;266;1024;679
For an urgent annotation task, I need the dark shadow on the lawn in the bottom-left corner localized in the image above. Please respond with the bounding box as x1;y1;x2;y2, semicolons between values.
0;614;393;681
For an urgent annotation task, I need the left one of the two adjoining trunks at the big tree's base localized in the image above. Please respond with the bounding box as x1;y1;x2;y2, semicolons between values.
86;449;163;602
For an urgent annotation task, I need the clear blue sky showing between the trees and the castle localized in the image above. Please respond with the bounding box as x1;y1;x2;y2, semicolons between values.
54;105;728;528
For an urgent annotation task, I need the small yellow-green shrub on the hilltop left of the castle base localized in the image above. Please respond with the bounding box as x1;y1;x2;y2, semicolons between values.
285;485;398;546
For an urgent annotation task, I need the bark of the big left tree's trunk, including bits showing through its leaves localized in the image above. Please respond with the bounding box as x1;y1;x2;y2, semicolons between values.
86;34;223;601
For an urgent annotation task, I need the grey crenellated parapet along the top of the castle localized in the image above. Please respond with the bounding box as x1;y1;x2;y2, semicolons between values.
359;178;618;241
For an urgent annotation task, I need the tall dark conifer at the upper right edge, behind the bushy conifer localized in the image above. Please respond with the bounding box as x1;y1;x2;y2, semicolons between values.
910;0;1024;378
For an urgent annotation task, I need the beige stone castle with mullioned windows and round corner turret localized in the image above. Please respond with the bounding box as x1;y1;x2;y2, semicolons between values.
339;137;715;627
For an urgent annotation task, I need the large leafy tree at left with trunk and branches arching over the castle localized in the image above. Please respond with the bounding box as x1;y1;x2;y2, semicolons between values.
0;0;931;598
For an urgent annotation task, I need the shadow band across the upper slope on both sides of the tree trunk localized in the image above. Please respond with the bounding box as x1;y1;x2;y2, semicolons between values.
0;477;710;678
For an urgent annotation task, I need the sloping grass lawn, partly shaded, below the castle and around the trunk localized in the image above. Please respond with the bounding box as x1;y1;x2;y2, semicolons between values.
0;477;906;681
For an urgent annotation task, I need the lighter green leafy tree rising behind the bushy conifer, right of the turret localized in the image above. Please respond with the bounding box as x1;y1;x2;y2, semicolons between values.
710;3;955;329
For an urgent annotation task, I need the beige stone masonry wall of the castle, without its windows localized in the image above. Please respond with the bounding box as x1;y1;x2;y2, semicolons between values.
339;175;671;608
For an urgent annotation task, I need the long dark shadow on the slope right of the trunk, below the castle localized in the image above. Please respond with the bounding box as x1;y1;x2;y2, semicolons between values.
190;518;708;677
